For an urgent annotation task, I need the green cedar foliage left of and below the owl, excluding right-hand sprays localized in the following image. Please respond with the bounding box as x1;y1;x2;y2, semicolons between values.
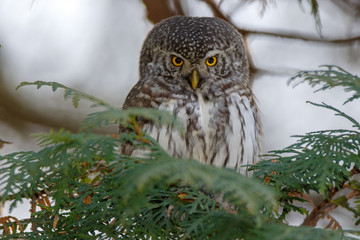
0;82;277;239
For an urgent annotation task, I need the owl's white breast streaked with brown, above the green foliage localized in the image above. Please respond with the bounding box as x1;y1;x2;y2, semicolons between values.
145;89;260;172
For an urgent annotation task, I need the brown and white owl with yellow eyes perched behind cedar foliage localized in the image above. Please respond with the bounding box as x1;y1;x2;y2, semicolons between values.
123;16;261;174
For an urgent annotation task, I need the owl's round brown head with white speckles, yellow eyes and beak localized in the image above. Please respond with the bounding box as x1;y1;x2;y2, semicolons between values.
140;16;249;93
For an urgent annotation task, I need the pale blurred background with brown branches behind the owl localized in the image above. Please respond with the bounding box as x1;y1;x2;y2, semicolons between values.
0;0;360;227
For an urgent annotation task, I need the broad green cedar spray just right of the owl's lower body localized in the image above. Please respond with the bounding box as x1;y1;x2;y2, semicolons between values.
251;130;360;194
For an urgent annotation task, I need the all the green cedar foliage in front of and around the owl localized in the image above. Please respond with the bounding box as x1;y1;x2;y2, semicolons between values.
0;66;360;240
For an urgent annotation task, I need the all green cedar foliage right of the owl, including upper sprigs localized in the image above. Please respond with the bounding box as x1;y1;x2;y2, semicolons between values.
251;66;360;232
